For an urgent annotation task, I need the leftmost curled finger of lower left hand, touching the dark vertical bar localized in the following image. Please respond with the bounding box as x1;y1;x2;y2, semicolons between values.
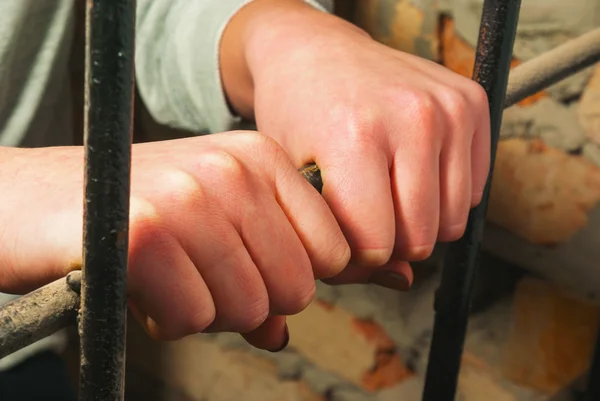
129;231;216;340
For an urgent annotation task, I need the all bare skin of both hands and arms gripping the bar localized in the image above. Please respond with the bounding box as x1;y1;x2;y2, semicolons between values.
0;0;490;350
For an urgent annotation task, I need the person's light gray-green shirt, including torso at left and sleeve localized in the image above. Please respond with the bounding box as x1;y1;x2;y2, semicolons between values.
0;0;333;370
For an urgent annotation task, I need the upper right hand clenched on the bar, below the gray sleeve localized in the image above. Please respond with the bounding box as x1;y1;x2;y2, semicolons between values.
225;0;490;282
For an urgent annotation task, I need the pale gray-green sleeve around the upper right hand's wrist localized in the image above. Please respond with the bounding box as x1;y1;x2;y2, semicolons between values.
135;0;333;133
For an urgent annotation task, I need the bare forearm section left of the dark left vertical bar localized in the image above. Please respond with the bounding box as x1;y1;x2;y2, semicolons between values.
0;147;83;293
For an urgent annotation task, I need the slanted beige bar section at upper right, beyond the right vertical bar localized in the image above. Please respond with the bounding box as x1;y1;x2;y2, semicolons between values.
504;28;600;108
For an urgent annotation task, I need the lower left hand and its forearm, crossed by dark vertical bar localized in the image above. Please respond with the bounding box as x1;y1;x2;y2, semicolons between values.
0;132;350;349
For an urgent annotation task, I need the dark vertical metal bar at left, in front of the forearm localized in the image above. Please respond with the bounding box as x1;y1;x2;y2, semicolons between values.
79;0;135;401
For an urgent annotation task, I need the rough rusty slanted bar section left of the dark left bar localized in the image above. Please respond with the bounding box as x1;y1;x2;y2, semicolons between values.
0;271;81;359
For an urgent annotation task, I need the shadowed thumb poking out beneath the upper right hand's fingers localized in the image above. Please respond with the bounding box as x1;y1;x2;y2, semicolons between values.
322;260;413;291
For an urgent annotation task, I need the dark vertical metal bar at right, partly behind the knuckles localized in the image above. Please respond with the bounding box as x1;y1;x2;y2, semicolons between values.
423;0;521;401
